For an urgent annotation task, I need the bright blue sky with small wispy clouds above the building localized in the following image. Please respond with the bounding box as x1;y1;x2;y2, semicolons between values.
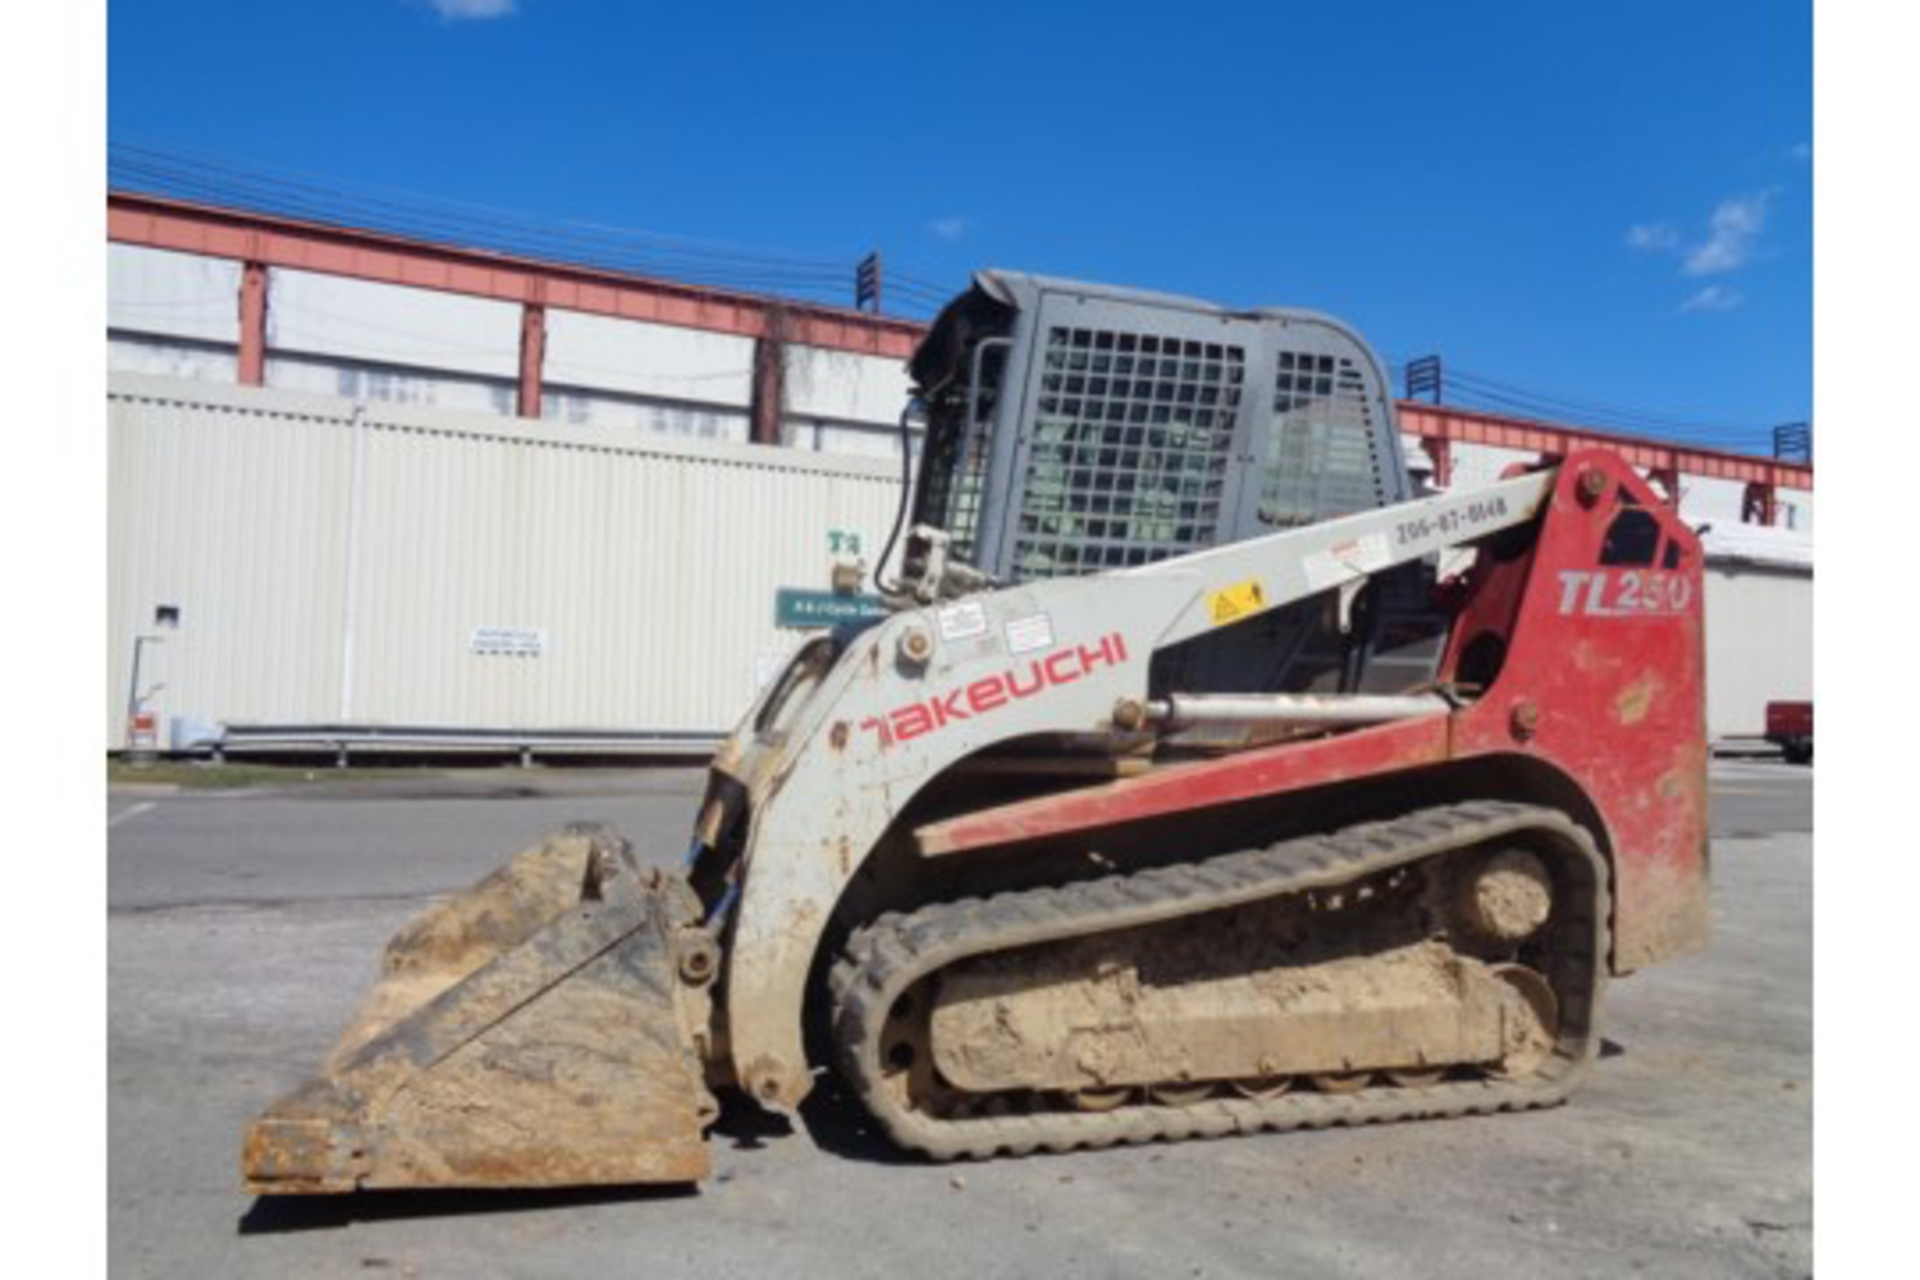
108;0;1812;445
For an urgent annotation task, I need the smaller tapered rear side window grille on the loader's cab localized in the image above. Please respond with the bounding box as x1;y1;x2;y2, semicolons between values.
1260;351;1390;528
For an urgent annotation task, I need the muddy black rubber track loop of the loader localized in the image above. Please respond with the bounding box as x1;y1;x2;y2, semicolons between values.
829;800;1609;1159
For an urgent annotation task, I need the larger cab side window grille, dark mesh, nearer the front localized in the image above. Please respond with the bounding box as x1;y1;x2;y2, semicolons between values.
1014;326;1246;578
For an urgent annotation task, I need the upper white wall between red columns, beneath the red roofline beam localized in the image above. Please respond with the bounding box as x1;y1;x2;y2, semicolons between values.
108;244;1812;502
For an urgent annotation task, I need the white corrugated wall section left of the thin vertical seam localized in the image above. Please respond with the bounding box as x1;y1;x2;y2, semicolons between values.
106;374;349;748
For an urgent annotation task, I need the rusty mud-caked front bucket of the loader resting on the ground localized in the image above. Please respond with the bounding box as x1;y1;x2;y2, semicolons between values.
240;827;718;1194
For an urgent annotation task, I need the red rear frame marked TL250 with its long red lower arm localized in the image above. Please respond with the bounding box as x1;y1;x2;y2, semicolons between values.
916;451;1707;971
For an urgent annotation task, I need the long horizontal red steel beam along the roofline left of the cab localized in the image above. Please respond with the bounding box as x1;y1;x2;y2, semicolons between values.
108;192;925;359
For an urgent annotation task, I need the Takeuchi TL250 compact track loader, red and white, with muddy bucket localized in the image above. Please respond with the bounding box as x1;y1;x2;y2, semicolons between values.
242;273;1707;1194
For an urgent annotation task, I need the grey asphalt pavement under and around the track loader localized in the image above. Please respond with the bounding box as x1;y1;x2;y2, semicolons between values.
106;762;1812;1280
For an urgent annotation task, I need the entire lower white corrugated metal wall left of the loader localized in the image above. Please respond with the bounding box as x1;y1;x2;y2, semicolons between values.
106;374;899;748
